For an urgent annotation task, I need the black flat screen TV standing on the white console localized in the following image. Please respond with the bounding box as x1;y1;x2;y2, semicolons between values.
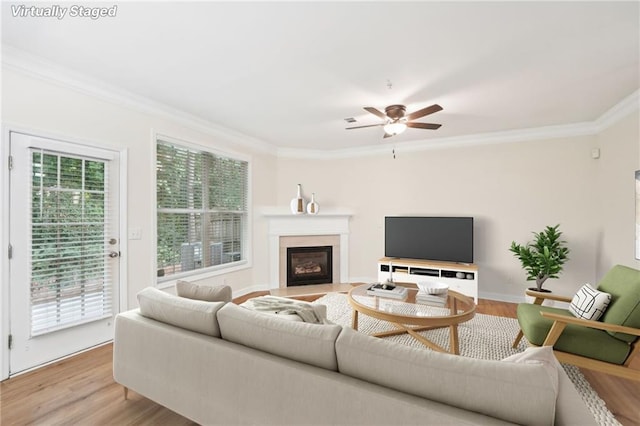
384;216;473;263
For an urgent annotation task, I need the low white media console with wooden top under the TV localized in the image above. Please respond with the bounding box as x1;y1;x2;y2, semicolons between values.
378;257;478;303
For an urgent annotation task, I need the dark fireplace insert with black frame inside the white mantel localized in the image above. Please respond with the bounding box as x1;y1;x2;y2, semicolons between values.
287;246;333;287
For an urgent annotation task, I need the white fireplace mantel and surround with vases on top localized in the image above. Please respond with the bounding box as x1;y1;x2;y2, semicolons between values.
262;207;352;288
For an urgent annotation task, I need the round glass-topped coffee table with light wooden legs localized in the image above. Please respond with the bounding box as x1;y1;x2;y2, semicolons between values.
347;284;476;355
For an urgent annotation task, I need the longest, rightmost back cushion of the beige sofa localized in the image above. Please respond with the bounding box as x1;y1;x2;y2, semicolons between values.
336;328;557;424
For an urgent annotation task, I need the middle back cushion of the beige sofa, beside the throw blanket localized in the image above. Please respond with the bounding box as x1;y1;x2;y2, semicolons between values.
218;303;342;371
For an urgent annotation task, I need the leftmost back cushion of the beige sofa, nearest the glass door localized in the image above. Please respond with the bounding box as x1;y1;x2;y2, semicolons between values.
138;287;225;337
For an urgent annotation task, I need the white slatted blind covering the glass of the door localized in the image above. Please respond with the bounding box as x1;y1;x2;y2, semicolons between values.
30;149;112;336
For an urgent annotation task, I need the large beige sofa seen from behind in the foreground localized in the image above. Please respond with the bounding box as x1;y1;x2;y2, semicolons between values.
113;288;595;425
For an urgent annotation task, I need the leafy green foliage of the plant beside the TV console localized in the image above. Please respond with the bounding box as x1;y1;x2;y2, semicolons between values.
509;224;569;292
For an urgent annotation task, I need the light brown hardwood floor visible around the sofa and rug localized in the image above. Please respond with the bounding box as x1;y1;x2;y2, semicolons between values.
0;292;640;426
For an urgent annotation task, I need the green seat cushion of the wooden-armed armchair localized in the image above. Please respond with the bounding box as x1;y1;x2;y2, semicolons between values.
518;303;630;364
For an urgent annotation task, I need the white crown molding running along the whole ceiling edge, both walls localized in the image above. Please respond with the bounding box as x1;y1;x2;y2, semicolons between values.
2;45;640;160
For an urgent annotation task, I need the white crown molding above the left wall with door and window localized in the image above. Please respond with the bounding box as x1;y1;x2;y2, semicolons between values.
2;44;277;155
